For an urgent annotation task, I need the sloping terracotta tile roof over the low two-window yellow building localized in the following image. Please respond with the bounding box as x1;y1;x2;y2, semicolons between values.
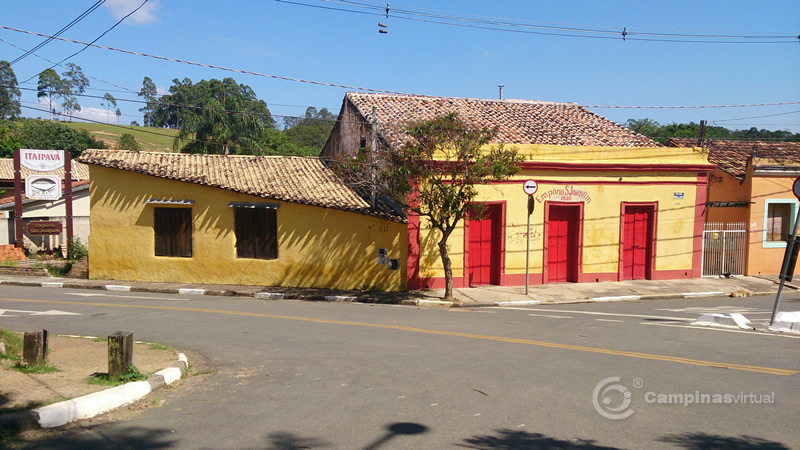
80;150;405;222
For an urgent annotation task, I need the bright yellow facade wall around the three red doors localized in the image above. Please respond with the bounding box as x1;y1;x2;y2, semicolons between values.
412;145;708;281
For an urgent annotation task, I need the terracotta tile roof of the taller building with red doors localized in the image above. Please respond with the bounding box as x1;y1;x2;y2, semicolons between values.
345;92;659;147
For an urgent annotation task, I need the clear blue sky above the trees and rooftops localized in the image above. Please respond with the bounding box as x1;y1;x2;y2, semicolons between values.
0;0;800;132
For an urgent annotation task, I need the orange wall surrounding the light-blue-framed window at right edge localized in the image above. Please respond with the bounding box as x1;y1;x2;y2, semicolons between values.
746;173;797;275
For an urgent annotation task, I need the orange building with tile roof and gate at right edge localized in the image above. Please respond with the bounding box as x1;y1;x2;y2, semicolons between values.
670;139;800;275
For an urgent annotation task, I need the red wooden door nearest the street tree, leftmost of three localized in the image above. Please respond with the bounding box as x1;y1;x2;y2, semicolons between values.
467;205;500;286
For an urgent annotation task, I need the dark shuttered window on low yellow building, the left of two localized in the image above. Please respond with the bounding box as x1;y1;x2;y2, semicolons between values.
153;208;192;258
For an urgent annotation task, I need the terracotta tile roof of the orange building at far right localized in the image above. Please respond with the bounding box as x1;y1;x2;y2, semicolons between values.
669;138;800;177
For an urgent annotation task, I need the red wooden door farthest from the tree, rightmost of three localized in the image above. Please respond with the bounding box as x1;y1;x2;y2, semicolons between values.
622;206;653;280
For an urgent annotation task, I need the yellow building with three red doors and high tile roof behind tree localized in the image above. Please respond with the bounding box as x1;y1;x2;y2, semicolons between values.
321;93;713;289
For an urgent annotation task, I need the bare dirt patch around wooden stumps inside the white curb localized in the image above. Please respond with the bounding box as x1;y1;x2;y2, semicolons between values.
0;336;177;410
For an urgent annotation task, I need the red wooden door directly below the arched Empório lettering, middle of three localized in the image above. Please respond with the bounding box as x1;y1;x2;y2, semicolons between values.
547;205;579;282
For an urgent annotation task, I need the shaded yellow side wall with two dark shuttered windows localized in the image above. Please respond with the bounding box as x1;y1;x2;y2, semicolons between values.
89;166;408;291
